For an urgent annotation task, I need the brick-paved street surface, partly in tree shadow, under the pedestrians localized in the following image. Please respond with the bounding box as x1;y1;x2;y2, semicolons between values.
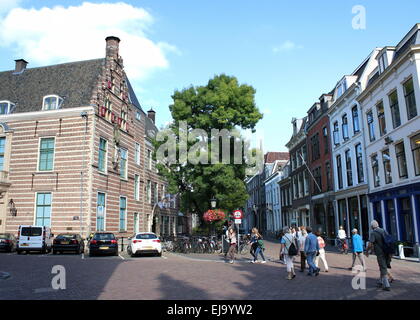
0;241;420;300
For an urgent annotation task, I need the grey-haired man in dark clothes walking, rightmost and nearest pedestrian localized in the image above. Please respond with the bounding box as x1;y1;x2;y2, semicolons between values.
366;220;391;291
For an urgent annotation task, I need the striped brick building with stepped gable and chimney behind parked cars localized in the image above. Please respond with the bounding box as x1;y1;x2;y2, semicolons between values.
0;37;191;237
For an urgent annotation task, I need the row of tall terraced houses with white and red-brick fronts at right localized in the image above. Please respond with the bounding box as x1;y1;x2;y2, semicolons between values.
247;24;420;258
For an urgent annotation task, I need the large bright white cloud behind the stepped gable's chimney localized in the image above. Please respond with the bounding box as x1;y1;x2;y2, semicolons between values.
0;0;180;80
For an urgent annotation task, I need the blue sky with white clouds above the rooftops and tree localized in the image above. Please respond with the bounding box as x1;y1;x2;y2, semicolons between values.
0;0;420;152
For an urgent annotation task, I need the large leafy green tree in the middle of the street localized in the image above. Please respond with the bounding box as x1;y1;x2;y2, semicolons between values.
155;74;262;222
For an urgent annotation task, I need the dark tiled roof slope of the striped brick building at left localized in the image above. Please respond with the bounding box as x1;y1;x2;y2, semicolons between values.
0;59;105;113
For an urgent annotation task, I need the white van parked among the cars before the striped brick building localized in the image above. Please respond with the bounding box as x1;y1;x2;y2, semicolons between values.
16;226;54;254
